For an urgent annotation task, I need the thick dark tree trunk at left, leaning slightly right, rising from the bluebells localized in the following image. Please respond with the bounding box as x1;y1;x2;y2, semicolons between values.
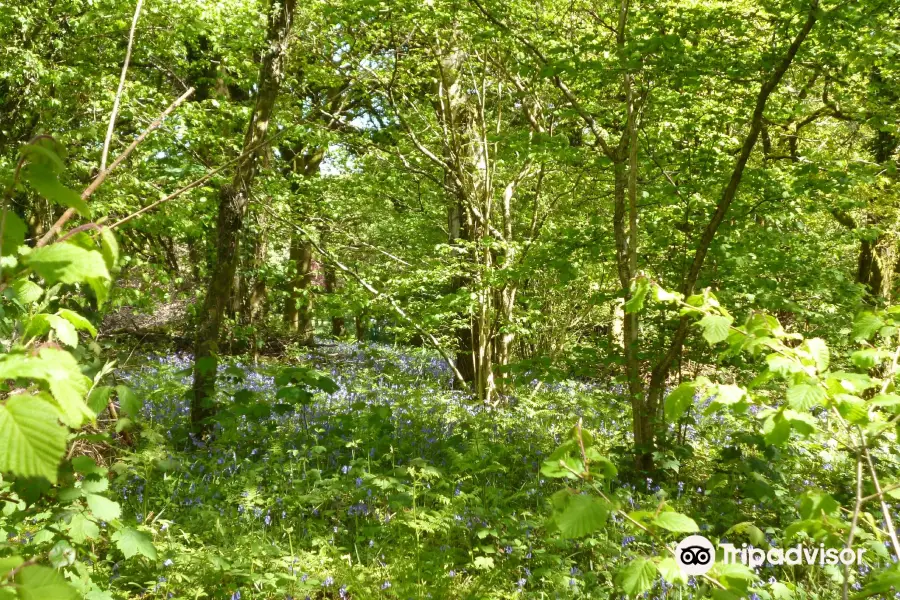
191;0;296;433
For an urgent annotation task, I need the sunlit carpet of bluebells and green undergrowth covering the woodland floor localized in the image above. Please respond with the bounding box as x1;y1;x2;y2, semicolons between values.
93;343;884;600
